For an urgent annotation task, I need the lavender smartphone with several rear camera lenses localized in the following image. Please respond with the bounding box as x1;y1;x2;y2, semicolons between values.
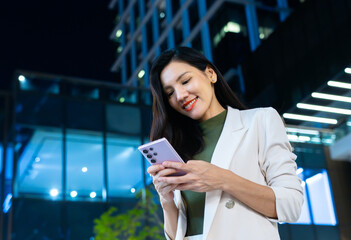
138;138;185;176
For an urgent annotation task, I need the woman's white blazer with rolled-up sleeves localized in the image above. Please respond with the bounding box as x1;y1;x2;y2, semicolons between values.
166;107;303;240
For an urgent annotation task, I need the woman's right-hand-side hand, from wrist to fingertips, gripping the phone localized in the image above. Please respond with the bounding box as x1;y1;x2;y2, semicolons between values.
158;160;227;192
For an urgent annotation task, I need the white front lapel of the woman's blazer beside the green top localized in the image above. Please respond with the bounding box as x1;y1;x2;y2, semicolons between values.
203;106;247;239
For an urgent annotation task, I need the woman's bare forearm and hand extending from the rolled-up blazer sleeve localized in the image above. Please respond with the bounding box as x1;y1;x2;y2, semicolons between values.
158;160;277;219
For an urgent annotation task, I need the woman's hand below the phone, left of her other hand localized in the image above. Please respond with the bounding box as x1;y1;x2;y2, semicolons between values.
147;164;177;204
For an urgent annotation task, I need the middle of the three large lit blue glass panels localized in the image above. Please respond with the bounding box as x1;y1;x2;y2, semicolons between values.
66;130;103;200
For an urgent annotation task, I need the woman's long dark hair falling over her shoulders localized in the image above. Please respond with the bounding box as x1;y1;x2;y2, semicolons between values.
150;47;246;161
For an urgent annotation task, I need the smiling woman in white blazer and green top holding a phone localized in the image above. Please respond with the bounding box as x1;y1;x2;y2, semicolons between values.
147;47;303;240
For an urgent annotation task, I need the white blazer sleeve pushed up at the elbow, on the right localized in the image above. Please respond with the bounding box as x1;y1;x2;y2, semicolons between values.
260;108;304;222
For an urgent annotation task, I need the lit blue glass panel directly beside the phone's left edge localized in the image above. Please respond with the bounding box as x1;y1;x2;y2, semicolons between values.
107;134;145;198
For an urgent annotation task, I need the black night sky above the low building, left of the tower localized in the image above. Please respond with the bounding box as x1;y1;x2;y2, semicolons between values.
0;0;118;89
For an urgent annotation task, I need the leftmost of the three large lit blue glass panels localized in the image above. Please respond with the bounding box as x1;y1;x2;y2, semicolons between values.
16;129;62;199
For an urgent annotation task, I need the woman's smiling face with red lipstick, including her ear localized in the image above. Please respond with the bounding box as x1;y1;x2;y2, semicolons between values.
161;61;224;121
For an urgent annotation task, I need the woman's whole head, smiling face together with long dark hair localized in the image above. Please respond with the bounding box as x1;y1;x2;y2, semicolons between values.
150;47;245;159
